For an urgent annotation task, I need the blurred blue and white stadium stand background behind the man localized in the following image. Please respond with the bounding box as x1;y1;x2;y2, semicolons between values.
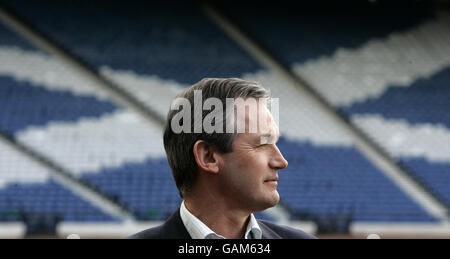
0;0;450;238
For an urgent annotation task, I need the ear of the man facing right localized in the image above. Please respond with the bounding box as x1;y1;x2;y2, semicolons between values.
192;140;220;174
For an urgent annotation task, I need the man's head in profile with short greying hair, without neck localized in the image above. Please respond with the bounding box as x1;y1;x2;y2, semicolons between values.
164;78;287;211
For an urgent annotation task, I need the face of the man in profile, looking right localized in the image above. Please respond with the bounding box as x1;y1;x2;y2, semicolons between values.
219;99;288;212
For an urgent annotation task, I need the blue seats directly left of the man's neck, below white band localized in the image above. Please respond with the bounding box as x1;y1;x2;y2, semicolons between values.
82;159;181;220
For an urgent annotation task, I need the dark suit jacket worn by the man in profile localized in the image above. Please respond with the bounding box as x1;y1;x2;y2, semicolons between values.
128;210;316;239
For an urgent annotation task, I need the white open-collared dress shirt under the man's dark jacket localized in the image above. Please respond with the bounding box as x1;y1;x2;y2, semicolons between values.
180;201;262;239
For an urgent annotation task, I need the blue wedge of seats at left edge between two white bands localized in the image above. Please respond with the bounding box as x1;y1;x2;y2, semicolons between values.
0;76;117;135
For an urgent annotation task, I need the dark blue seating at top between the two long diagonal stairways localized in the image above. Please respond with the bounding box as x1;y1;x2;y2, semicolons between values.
0;0;261;84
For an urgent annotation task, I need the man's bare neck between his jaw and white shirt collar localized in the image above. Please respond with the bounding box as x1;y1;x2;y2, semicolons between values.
184;196;250;239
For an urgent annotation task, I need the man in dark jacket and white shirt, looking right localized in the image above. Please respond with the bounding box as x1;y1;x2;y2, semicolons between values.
130;78;315;239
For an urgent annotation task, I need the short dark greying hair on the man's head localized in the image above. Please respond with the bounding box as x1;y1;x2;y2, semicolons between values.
164;78;270;198
